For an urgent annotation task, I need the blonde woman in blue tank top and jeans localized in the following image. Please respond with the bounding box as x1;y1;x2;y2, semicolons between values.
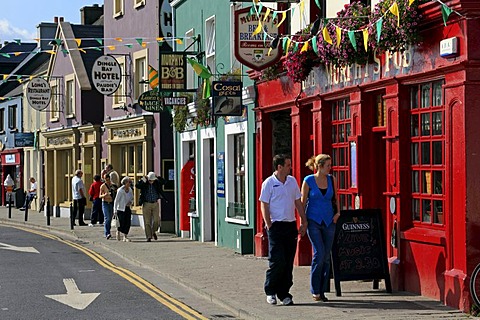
302;154;340;302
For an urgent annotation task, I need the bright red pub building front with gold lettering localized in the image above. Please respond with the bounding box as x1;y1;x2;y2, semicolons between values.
255;0;480;311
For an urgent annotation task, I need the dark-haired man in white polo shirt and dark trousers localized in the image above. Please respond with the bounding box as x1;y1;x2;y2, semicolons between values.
259;155;307;305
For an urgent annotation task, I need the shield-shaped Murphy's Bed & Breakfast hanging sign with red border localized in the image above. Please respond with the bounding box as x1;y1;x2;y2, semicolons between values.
235;8;282;71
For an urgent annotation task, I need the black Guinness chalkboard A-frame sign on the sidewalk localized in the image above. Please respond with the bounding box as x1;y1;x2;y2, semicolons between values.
332;209;392;296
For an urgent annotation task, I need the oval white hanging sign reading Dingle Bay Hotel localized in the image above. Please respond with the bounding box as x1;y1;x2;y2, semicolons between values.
92;56;122;96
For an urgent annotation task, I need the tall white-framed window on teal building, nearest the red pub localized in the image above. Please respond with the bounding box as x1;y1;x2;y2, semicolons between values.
225;123;248;223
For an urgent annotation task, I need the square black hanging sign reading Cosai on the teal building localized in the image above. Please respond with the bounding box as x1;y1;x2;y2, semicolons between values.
212;81;243;116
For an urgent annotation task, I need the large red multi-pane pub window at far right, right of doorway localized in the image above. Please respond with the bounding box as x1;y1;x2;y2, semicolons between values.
410;80;445;225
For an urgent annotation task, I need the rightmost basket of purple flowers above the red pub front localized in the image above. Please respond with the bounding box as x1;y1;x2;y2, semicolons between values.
369;0;425;53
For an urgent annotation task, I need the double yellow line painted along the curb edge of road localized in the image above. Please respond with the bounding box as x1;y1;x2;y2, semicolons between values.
13;226;208;320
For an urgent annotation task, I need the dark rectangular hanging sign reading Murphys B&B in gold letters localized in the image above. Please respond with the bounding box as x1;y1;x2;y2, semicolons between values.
158;52;190;92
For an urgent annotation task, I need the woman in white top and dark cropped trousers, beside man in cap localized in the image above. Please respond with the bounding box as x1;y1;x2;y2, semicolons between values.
113;177;133;242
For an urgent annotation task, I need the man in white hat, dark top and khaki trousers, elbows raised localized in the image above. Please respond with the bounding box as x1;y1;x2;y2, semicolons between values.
135;172;165;242
